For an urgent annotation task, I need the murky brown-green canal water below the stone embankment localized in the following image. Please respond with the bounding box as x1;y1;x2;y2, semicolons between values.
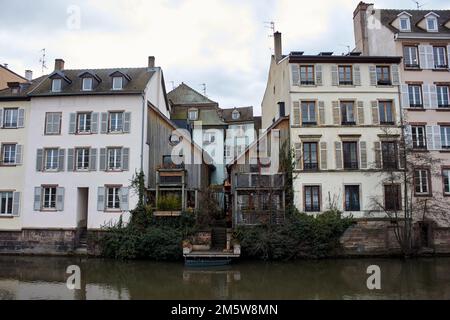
0;256;450;300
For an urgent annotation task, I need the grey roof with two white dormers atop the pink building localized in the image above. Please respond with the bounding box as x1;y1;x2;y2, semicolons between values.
380;9;450;34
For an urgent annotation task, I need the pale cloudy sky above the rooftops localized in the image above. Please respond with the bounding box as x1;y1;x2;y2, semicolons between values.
0;0;450;114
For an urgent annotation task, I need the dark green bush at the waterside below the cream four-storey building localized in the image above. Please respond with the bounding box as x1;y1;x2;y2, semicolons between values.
235;211;353;260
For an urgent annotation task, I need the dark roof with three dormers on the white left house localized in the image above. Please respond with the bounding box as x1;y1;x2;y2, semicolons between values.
30;68;155;96
